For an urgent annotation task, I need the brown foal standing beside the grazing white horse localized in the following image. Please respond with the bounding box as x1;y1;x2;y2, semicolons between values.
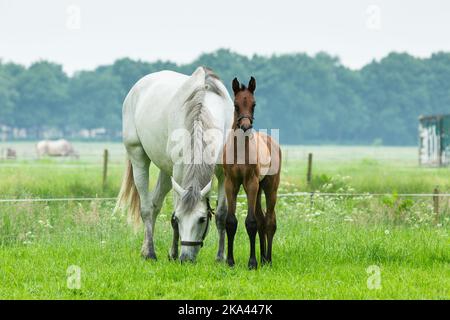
223;77;281;269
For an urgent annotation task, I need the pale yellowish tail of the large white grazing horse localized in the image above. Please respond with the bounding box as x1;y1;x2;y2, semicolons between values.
114;160;141;224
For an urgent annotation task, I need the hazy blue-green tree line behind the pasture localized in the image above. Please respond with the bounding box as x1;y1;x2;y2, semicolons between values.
0;49;450;145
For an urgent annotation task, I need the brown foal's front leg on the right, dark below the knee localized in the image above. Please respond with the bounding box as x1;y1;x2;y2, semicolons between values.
244;176;259;269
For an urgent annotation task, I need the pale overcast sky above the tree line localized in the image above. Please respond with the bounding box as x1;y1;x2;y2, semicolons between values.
0;0;450;73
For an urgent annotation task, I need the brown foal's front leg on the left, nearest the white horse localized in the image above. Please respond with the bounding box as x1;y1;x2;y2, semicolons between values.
225;177;240;267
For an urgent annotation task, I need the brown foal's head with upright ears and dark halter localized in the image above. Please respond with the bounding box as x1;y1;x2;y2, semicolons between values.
232;77;256;131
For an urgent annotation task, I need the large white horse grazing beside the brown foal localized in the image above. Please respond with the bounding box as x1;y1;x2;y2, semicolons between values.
116;67;234;261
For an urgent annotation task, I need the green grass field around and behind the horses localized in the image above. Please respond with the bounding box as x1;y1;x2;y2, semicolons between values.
0;143;450;299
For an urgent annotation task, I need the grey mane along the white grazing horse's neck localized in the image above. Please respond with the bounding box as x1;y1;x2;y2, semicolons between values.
181;67;224;211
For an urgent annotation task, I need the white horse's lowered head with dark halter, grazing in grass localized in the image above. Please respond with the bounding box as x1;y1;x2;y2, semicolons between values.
172;178;213;262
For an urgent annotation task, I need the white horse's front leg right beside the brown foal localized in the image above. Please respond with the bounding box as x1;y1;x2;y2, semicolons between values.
216;172;227;262
